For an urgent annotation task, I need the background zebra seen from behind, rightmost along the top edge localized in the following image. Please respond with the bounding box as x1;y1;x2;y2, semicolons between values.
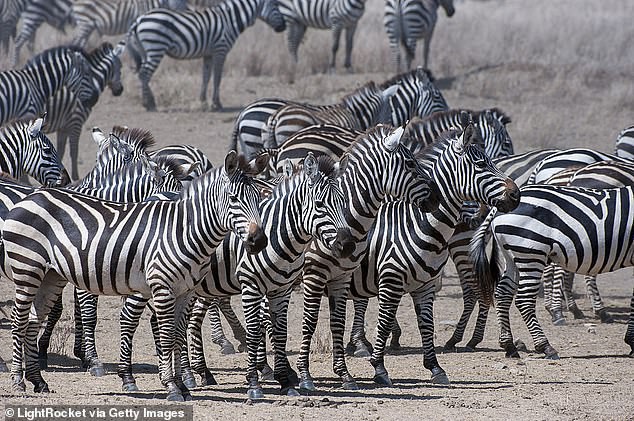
383;0;455;72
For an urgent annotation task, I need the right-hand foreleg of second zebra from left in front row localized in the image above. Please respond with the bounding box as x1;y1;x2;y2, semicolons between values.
269;288;299;396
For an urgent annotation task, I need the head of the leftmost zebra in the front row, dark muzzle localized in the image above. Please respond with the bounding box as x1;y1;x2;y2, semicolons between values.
217;151;268;253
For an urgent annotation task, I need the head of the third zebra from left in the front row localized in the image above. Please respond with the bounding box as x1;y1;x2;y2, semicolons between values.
344;125;440;212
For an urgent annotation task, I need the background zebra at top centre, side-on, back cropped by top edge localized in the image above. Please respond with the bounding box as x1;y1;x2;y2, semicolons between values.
280;0;365;72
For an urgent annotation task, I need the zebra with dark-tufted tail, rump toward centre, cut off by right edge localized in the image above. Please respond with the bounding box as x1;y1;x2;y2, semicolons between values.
471;184;634;359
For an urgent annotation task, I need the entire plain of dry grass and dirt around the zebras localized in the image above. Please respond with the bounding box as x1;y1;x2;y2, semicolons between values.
0;0;634;420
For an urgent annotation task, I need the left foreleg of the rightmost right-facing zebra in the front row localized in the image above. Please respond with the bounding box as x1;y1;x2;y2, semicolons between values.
370;286;404;386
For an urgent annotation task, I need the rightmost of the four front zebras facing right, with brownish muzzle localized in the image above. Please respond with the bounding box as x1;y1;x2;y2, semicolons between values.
340;124;520;385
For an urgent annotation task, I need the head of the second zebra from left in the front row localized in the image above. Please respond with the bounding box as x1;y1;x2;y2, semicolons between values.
303;152;355;258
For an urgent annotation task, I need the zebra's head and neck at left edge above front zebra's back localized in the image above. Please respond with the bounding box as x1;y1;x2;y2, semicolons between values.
0;118;70;187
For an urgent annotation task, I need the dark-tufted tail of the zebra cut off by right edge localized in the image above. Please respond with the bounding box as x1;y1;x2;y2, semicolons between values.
469;207;500;305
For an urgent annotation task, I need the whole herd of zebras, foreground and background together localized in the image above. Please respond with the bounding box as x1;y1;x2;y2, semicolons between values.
0;0;634;401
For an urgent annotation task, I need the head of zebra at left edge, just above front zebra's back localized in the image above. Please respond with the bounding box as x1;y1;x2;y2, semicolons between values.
22;118;70;187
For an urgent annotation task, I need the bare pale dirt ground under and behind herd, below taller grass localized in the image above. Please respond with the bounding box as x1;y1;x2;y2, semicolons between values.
0;2;634;421
